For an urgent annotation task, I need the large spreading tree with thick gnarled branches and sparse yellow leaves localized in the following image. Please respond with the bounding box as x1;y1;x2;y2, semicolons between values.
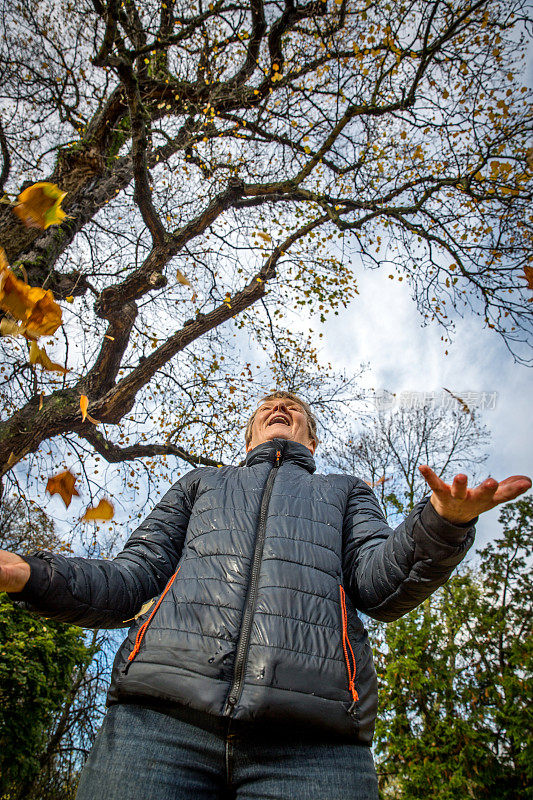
0;0;532;504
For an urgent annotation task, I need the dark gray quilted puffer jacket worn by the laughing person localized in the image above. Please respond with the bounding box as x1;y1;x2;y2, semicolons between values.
10;439;478;744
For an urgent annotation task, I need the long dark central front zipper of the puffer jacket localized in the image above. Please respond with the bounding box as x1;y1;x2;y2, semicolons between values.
223;450;281;716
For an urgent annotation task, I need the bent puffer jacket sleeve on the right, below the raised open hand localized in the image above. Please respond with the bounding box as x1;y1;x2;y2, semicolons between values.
343;478;479;622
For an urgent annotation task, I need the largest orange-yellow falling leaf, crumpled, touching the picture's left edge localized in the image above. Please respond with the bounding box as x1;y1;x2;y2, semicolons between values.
0;248;61;339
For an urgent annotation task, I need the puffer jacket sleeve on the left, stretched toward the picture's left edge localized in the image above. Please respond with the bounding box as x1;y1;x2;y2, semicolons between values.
8;470;199;628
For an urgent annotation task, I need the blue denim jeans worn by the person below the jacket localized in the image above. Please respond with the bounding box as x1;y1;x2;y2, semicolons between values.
76;703;378;800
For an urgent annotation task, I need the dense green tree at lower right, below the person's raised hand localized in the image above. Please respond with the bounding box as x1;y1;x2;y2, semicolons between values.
374;495;533;800
